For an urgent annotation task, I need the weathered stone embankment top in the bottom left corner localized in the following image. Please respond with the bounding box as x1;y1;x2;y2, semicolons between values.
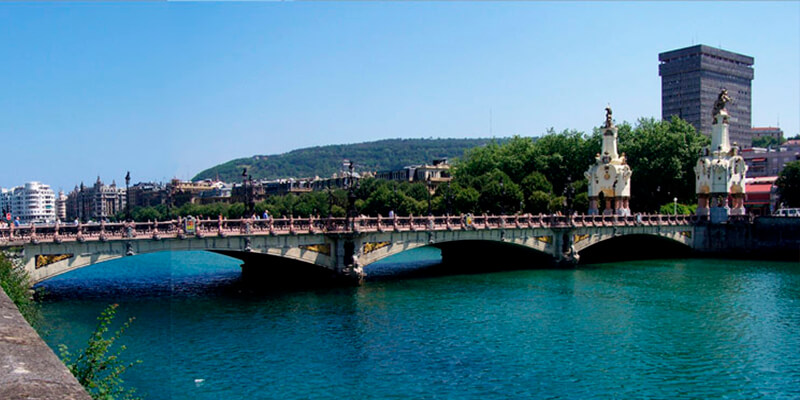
0;289;91;400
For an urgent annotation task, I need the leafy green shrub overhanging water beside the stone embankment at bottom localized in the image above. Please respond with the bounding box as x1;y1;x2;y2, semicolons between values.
59;304;141;400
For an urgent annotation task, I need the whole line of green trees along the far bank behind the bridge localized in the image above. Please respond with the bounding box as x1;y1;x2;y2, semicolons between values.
118;117;798;221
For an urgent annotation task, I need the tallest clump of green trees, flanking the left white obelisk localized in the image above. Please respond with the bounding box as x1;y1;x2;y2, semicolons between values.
454;118;708;213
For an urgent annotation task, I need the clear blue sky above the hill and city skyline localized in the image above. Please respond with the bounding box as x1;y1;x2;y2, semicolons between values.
0;1;800;192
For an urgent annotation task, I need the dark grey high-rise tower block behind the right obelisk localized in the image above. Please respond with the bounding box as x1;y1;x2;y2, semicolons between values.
658;45;754;146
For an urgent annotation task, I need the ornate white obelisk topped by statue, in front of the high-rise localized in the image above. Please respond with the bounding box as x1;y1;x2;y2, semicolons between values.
694;89;747;223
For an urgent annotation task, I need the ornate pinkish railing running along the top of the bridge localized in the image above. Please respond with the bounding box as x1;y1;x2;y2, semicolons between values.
0;214;700;246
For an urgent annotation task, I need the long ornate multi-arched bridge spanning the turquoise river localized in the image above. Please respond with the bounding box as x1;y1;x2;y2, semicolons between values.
0;214;728;283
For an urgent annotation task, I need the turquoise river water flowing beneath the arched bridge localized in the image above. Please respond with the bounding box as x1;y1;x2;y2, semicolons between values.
34;251;800;400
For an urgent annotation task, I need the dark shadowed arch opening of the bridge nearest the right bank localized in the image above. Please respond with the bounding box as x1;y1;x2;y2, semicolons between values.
579;235;692;264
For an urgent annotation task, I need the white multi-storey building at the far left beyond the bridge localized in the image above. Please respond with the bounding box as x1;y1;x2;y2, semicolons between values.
0;182;56;224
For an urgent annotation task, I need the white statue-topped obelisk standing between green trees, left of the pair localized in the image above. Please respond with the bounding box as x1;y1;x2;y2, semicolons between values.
584;107;633;215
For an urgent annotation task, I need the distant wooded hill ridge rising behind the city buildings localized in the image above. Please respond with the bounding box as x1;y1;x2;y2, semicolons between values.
192;138;508;182
